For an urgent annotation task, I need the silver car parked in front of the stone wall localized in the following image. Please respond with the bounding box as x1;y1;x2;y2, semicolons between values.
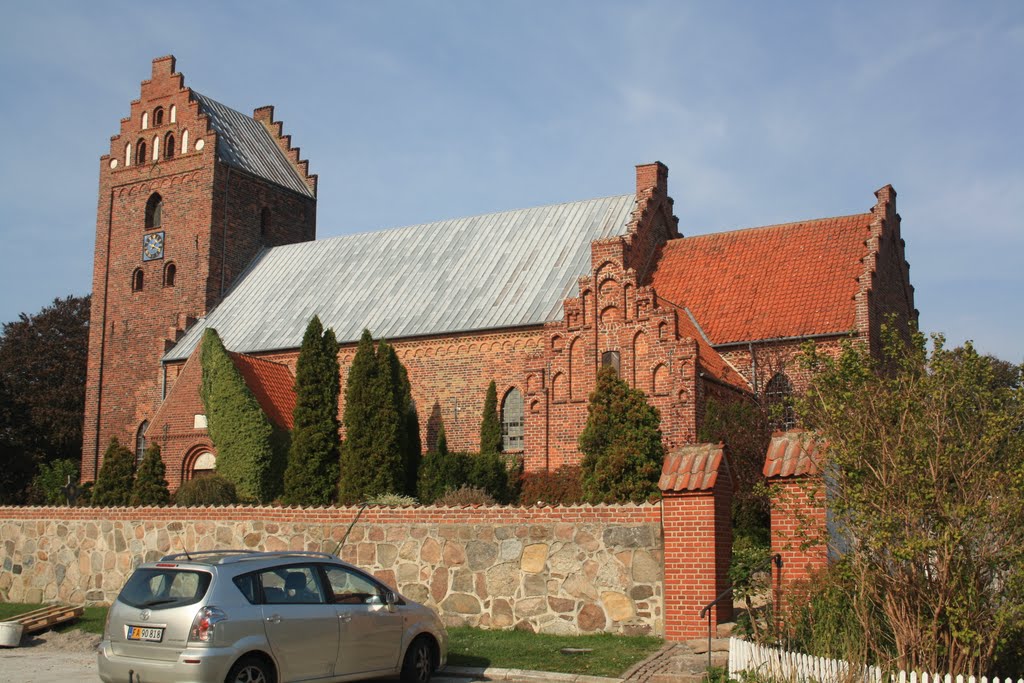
98;550;447;683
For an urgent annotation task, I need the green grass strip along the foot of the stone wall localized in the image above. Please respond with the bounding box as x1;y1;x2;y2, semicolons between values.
0;603;663;676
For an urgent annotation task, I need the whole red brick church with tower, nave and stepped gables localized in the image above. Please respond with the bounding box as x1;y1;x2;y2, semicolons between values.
82;56;916;488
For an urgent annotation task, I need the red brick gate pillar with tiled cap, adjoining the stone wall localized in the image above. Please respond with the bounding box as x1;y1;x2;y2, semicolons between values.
658;443;732;641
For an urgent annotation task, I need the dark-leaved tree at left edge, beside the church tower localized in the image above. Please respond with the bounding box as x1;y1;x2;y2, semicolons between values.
0;296;89;504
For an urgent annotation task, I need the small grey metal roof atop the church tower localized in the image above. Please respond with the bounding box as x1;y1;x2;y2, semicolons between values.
191;90;313;197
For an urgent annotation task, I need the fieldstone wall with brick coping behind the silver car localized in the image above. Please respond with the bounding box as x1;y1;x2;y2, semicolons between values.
0;505;665;635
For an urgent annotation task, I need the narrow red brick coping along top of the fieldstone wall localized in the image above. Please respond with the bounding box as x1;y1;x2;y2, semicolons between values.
0;502;662;524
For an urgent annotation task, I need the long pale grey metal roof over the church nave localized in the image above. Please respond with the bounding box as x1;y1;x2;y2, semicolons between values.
165;195;636;360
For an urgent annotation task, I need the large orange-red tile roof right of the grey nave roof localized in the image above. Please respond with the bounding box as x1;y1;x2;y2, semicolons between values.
652;213;872;344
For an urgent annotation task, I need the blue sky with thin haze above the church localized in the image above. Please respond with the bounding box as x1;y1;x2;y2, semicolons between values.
0;0;1024;362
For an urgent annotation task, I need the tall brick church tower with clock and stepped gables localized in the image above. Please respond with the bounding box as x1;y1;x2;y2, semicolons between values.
82;56;316;481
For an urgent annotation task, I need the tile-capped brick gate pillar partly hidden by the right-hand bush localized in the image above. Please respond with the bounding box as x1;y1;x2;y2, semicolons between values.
764;430;828;616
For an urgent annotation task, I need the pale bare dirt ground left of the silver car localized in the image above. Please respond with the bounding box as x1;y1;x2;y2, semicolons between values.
0;630;99;683
